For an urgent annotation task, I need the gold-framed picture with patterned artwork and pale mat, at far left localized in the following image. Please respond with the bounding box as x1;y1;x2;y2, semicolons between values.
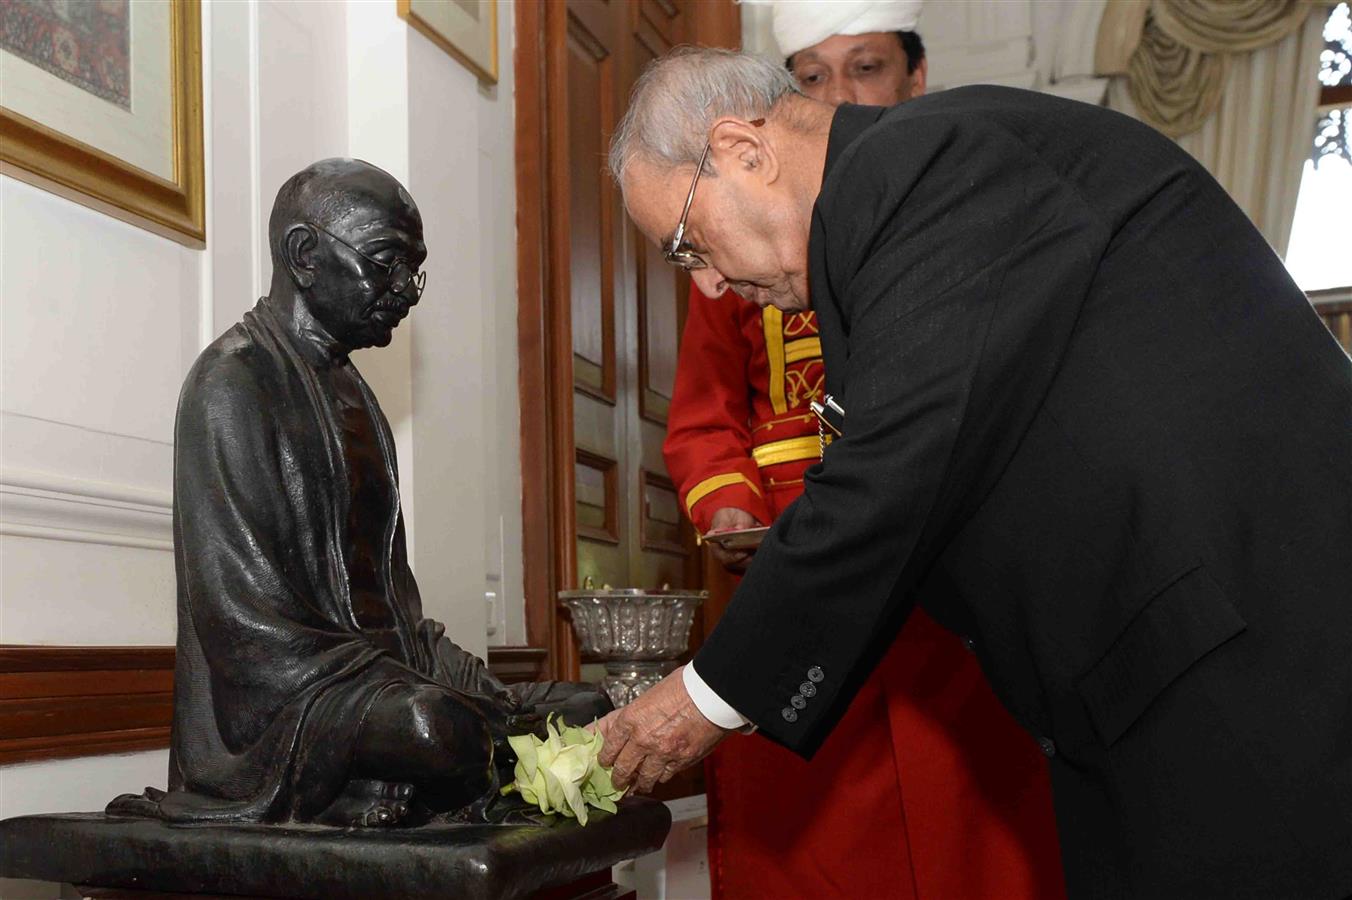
0;0;207;247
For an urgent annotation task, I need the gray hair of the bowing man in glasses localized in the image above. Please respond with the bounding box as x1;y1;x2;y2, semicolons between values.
610;47;799;184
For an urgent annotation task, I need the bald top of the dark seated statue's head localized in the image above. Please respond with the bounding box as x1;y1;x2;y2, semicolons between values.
268;157;422;268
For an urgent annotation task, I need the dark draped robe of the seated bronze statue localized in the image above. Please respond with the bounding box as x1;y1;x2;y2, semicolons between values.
145;299;519;822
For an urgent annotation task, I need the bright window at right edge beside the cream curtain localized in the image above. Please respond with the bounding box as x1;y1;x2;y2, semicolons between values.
1286;3;1352;292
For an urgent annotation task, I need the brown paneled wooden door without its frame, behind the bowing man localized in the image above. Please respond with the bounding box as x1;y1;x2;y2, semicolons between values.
565;0;698;588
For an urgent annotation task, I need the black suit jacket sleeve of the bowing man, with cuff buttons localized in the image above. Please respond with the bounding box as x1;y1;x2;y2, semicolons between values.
695;111;1107;757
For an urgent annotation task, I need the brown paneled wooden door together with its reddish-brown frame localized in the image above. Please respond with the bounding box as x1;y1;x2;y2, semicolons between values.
515;0;737;677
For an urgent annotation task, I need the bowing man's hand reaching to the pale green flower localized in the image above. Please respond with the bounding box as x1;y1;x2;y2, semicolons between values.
596;669;733;793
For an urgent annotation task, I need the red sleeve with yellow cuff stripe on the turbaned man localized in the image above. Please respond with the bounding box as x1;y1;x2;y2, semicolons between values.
662;285;772;534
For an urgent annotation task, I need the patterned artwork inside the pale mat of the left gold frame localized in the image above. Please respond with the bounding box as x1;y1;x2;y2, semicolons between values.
0;0;131;109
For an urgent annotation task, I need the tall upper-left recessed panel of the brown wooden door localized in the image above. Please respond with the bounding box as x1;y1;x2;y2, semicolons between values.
566;8;617;403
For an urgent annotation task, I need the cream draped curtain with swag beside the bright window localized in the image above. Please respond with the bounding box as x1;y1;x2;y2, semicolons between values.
1095;0;1326;254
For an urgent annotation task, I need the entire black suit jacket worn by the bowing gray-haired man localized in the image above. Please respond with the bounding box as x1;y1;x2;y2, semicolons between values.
695;88;1352;899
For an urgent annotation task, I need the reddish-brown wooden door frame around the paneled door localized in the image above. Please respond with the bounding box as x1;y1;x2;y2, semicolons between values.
512;0;741;680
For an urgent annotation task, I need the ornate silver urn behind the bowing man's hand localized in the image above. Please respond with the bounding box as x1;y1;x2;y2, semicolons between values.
558;588;708;707
